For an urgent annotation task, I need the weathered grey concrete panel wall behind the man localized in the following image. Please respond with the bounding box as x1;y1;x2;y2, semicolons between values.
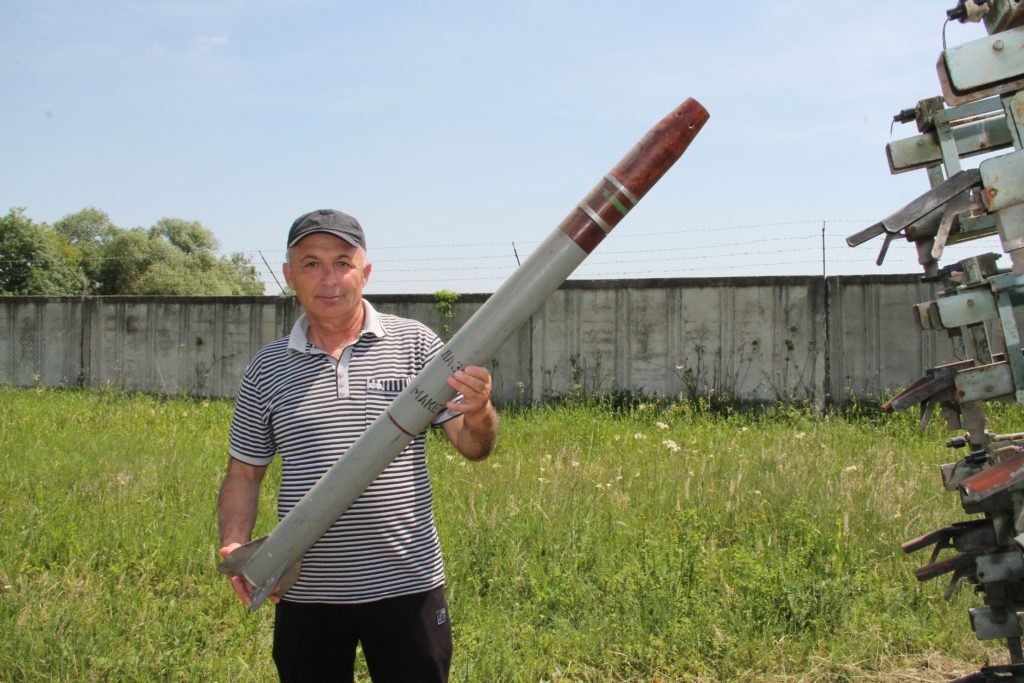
0;275;949;402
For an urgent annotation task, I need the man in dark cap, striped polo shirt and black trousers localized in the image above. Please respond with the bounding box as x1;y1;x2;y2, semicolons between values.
217;210;498;683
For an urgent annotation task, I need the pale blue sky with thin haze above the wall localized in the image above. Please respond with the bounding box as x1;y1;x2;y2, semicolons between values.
0;0;1000;294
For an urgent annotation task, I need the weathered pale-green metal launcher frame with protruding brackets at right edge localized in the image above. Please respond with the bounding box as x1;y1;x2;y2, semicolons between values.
847;0;1024;682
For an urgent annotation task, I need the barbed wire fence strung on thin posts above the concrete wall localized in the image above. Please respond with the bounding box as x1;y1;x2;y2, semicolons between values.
245;219;1000;294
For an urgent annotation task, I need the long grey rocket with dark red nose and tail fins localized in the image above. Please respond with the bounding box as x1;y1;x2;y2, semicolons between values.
218;98;708;611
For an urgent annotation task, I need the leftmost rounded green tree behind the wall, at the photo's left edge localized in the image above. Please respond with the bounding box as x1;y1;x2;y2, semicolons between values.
0;208;89;296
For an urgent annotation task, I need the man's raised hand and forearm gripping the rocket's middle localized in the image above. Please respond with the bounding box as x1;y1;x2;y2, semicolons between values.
444;366;498;460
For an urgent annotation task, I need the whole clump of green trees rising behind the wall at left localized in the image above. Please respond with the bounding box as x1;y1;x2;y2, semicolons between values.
0;207;263;296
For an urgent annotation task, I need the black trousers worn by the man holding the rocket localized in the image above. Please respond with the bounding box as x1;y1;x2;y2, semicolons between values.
273;586;452;683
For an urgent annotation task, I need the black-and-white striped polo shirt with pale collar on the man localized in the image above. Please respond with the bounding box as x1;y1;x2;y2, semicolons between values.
229;300;455;604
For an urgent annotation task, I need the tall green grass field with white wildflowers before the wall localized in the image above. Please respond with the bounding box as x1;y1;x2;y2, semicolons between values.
0;387;1024;683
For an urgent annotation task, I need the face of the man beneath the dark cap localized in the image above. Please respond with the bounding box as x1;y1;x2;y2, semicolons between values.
285;232;371;321
